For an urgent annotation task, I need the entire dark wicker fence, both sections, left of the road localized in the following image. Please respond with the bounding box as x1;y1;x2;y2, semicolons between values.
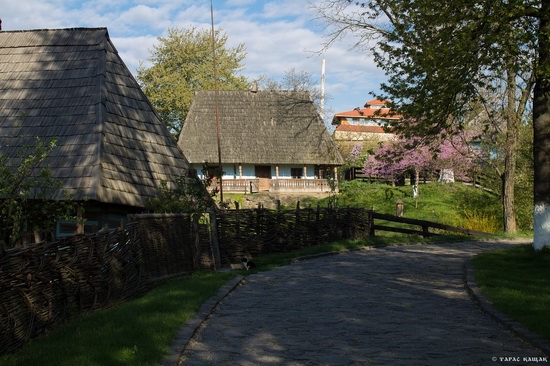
0;208;369;354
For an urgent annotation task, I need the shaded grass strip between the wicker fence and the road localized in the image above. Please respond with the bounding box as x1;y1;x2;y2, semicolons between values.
0;235;464;366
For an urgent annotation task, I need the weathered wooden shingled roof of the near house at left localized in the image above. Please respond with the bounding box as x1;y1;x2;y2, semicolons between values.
0;28;187;207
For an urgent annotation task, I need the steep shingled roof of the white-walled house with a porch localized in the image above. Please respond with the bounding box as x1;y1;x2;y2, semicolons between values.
178;91;343;165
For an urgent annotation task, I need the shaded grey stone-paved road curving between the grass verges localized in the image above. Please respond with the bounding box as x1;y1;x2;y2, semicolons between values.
179;243;550;365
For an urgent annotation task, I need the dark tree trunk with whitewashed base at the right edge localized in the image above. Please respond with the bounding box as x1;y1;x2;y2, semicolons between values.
533;0;550;250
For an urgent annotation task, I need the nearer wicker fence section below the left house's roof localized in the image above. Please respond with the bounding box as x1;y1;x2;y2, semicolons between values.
0;214;212;354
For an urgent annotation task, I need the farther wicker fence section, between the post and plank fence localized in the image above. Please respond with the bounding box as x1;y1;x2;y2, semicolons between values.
217;208;370;265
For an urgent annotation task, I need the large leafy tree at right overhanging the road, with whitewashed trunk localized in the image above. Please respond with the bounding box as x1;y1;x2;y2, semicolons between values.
317;0;550;248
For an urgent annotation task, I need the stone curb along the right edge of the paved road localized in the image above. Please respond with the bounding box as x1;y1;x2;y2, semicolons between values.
464;259;550;356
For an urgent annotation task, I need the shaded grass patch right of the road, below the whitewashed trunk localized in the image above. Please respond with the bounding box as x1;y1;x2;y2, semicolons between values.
473;245;550;340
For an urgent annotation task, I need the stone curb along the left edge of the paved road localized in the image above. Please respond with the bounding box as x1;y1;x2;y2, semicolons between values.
158;276;244;366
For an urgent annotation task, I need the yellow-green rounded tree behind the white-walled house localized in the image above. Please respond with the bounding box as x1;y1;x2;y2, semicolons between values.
137;27;249;137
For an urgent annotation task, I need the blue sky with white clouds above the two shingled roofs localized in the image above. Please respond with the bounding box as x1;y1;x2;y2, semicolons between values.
0;0;384;126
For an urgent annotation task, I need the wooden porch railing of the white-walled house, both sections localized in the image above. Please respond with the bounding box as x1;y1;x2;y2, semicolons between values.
223;178;331;193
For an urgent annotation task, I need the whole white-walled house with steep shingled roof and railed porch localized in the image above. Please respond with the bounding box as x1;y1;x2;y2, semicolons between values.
178;91;343;192
